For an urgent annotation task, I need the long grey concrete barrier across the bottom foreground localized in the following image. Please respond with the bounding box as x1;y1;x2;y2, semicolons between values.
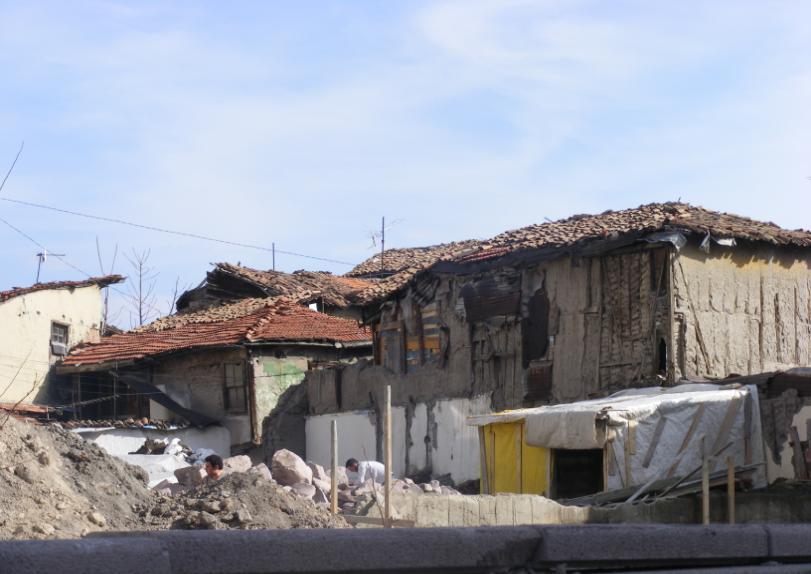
0;524;811;574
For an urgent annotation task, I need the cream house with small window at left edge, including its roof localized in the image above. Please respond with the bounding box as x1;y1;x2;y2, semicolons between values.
0;275;124;405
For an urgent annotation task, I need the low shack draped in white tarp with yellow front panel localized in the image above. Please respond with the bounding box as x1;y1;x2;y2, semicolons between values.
468;384;766;500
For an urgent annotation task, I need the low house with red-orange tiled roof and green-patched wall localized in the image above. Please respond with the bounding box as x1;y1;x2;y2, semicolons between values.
58;297;372;452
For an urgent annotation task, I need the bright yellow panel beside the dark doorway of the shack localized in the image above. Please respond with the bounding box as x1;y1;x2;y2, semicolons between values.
482;421;550;494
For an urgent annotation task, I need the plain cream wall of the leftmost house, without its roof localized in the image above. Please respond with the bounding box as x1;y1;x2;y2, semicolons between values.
0;285;101;403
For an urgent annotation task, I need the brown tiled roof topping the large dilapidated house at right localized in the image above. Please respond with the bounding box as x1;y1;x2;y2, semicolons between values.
456;202;811;262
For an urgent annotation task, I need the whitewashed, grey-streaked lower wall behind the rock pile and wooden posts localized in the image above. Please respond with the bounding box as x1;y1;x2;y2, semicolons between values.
306;397;490;483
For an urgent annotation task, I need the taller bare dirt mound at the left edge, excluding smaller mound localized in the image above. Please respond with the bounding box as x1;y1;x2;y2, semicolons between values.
0;413;152;539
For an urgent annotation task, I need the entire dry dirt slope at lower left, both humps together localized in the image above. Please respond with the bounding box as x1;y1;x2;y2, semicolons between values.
0;412;347;539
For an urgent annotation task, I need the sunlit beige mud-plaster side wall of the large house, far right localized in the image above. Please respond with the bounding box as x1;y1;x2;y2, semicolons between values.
673;245;811;377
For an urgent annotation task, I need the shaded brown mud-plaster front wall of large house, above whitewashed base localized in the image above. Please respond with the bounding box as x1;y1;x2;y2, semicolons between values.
306;248;672;424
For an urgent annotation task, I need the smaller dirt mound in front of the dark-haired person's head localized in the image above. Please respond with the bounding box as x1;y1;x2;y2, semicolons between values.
139;473;348;530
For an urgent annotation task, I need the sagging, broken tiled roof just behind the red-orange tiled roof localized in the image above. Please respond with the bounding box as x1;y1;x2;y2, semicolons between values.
178;263;372;309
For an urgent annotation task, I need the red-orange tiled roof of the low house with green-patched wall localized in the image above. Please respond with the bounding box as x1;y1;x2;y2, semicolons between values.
63;298;371;365
